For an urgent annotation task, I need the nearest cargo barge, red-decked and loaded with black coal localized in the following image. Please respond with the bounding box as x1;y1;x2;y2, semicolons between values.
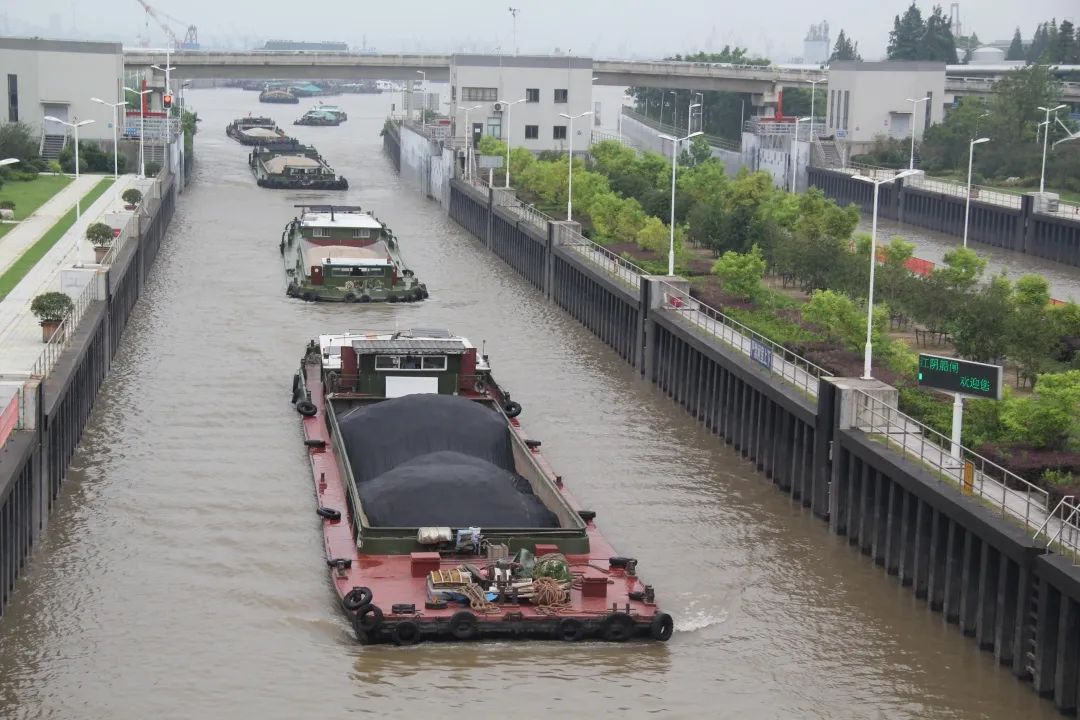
293;330;673;646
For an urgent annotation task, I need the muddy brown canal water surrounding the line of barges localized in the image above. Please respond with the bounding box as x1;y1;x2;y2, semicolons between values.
0;90;1057;720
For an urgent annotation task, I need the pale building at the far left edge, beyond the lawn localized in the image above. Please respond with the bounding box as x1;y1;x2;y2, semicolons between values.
0;38;124;144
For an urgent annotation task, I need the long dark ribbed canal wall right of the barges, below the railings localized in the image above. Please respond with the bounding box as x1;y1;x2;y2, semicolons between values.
440;172;1080;711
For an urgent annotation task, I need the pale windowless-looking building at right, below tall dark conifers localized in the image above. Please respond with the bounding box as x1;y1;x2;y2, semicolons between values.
824;62;945;152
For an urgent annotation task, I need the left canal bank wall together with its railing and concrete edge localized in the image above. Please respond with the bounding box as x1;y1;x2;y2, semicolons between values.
0;168;180;614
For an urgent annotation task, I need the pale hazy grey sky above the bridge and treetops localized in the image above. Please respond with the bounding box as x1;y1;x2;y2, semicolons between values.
8;0;1080;62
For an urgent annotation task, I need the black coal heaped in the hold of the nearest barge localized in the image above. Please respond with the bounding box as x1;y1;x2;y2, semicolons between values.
338;394;558;528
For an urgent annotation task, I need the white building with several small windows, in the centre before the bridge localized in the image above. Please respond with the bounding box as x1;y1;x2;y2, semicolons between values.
449;55;594;152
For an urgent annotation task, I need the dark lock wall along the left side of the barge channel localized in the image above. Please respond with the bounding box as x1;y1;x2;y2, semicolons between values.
0;155;179;614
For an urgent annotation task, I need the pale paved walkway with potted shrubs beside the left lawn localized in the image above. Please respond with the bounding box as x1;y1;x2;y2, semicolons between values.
0;175;145;376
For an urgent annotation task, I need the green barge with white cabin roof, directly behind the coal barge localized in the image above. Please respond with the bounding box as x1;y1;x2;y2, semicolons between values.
280;205;428;302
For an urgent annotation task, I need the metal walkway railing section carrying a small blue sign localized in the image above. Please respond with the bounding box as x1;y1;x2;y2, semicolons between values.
660;281;829;397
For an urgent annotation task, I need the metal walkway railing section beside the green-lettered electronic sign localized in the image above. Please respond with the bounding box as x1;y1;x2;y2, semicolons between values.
854;390;1050;531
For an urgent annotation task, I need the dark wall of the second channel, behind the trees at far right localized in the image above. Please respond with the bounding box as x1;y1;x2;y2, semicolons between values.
809;167;1080;266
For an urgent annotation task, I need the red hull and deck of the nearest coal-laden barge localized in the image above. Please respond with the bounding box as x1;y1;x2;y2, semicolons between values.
294;363;672;644
